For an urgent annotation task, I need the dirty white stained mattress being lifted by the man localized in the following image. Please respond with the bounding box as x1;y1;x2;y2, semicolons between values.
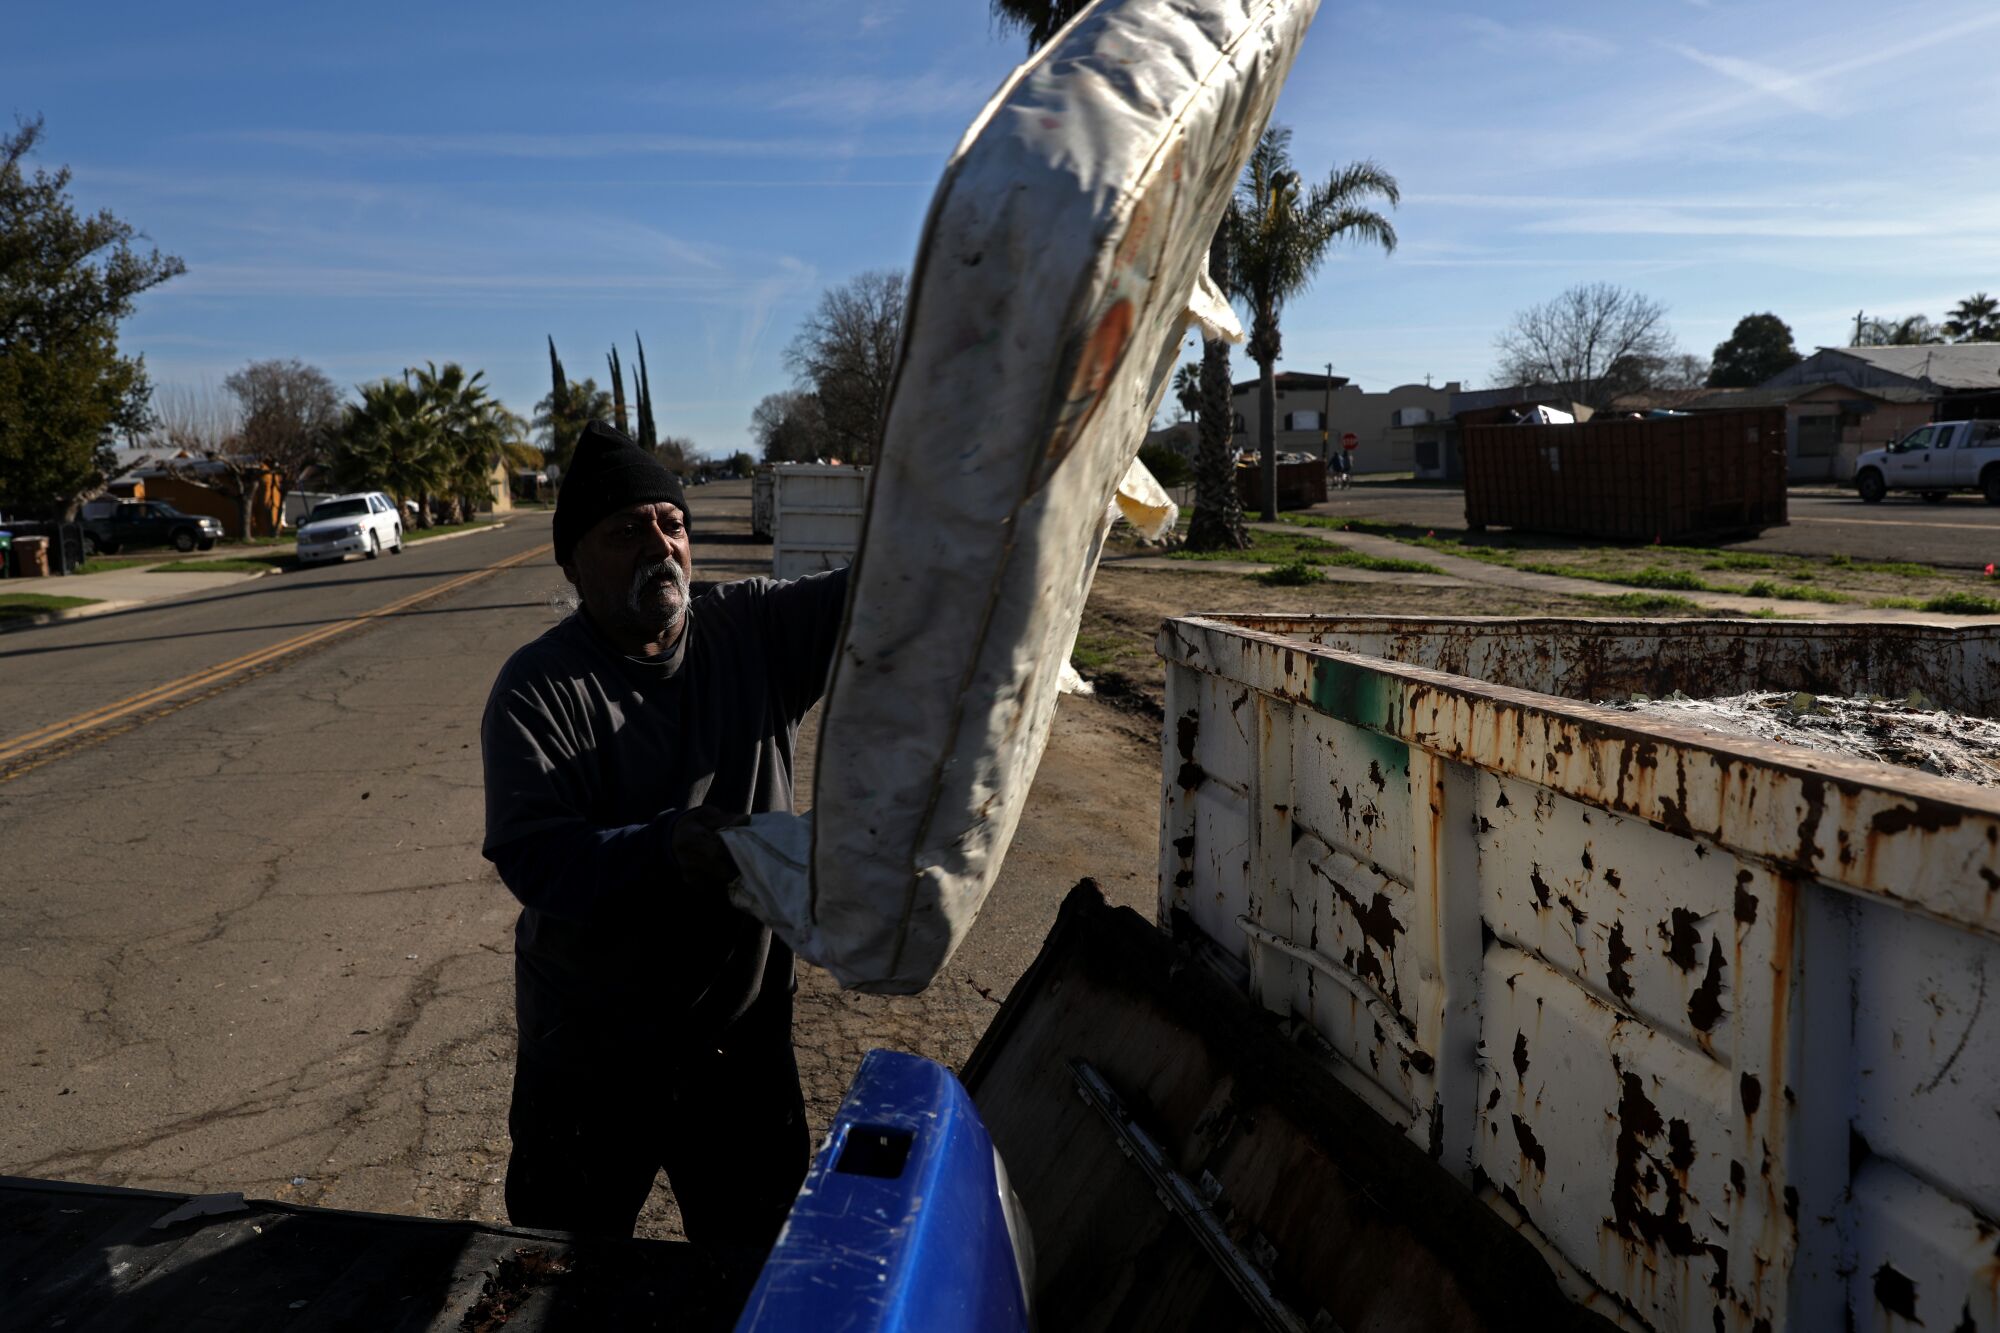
724;0;1318;980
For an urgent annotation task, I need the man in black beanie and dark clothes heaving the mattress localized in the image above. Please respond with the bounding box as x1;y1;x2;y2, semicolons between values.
480;422;848;1247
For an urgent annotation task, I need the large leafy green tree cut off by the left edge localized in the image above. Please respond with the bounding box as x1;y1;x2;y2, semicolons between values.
0;118;186;516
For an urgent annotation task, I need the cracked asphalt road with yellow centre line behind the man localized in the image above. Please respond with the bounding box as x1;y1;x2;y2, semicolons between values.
0;484;1158;1235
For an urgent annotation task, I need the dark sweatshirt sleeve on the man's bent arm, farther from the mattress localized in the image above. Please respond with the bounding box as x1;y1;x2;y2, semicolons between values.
480;671;680;925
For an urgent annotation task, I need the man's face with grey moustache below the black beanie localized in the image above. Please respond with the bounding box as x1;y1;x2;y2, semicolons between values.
562;500;694;652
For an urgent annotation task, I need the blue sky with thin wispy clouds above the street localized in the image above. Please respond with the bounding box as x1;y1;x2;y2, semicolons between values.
0;0;2000;452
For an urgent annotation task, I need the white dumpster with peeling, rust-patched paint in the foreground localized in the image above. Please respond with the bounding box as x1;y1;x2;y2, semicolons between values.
1160;616;2000;1333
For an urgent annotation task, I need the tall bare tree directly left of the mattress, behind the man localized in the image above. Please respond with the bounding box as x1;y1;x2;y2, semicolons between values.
784;270;904;462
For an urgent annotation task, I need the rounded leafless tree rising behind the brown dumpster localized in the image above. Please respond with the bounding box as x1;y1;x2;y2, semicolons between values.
1494;282;1680;406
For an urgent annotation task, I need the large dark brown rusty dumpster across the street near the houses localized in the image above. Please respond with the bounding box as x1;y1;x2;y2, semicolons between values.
1462;408;1786;542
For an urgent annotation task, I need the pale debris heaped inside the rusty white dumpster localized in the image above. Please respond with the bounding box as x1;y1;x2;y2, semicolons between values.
1616;691;2000;787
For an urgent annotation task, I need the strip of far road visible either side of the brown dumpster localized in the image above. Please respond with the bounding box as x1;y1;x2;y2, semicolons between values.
1314;482;2000;568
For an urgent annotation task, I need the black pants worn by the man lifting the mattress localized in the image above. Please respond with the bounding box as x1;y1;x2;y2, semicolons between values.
506;985;812;1249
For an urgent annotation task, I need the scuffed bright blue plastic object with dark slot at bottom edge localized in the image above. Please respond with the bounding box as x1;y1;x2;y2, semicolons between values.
736;1051;1032;1333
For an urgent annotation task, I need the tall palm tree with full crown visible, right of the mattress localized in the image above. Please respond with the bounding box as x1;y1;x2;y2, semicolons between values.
1226;126;1402;522
